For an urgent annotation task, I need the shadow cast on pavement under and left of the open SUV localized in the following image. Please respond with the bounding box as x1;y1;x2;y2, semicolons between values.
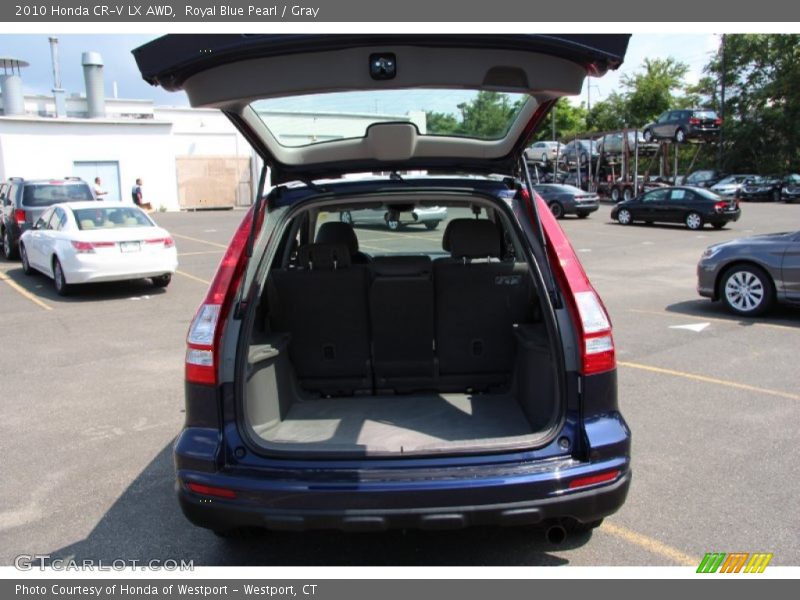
39;444;591;566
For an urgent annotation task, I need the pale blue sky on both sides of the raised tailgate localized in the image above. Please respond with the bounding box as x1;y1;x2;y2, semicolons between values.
0;33;719;110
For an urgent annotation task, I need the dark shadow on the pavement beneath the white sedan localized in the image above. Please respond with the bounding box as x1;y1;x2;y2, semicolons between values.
4;266;167;303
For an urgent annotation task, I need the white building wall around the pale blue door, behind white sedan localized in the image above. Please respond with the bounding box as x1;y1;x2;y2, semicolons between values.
0;117;179;210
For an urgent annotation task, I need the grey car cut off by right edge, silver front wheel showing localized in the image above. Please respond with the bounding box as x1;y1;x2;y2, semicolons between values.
697;231;800;317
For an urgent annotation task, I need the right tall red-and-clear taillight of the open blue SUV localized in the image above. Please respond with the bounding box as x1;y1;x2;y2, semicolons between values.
523;195;617;375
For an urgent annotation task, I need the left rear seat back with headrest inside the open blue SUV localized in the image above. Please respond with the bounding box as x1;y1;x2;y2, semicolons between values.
268;244;372;395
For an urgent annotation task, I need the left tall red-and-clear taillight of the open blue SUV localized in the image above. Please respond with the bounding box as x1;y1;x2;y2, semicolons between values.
186;208;263;385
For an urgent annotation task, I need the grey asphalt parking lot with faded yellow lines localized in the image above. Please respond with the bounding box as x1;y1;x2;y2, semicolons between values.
0;204;800;566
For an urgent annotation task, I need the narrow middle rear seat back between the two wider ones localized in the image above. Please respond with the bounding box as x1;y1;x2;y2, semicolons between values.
369;256;435;392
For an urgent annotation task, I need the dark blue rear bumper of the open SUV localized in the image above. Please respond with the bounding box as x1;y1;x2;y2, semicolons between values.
176;458;631;531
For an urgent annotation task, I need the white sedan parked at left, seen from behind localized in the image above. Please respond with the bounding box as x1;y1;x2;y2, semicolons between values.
19;201;178;295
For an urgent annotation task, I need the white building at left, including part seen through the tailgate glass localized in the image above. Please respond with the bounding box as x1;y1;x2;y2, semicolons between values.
0;88;425;210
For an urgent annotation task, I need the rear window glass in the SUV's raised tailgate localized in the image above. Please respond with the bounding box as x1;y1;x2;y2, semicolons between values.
250;89;529;146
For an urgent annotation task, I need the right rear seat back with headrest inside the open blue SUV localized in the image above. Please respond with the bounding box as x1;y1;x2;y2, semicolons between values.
434;219;534;391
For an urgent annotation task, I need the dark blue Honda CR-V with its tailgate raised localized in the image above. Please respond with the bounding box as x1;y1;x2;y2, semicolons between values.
134;35;631;541
